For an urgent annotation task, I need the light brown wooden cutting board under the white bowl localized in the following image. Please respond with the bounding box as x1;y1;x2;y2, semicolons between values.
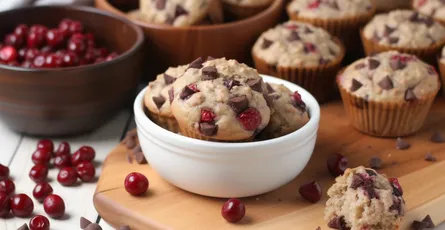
94;99;445;230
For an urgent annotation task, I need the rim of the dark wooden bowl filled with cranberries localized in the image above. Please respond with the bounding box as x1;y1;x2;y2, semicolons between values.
0;5;145;73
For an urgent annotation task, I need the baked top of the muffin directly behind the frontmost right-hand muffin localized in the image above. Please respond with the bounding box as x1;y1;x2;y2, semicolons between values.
363;10;445;48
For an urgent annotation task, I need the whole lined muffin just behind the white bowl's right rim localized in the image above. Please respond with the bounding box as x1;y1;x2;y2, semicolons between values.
252;21;345;102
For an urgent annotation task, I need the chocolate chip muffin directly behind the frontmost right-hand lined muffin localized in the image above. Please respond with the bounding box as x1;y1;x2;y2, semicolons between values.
362;10;445;64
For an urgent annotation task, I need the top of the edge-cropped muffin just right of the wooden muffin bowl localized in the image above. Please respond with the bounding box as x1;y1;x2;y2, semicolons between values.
287;0;373;19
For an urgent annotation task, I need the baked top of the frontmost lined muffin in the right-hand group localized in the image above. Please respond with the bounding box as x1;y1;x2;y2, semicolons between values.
338;51;440;102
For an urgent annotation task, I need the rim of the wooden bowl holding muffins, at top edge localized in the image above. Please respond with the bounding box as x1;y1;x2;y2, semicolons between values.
96;0;284;31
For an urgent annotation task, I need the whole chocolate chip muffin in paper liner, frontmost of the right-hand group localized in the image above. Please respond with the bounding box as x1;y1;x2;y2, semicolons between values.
337;51;440;137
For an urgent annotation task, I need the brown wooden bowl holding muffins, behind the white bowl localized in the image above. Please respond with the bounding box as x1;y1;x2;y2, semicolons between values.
96;0;284;79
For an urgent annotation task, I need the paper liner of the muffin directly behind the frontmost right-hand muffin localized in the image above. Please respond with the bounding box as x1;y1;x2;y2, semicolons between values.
360;29;445;66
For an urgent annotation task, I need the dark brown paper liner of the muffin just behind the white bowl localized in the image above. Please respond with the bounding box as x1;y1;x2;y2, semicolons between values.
252;39;345;103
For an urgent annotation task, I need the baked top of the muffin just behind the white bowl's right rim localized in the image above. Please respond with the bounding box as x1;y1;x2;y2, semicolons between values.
253;21;343;67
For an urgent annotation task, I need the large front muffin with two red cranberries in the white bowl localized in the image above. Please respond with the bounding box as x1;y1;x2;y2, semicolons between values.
172;58;270;142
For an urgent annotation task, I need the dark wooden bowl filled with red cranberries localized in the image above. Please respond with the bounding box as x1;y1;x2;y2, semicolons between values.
0;6;144;136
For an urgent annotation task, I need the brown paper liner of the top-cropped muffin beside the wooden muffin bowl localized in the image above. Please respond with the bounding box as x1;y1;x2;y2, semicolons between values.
287;6;376;55
